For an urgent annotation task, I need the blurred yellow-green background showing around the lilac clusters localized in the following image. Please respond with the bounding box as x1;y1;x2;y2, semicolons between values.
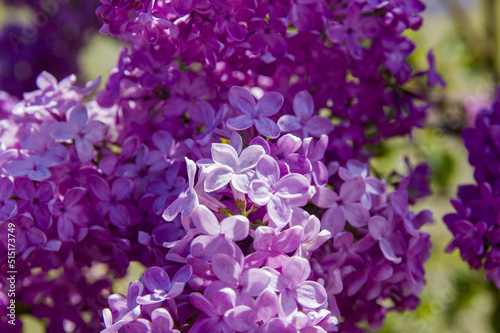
0;0;500;333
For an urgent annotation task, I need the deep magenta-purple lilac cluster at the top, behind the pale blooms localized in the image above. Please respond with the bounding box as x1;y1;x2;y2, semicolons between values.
97;0;442;163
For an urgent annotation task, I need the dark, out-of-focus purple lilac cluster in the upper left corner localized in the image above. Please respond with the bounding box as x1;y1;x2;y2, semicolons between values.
0;0;99;98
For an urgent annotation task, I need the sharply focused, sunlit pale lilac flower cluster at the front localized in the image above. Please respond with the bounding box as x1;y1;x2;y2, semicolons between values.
99;135;431;332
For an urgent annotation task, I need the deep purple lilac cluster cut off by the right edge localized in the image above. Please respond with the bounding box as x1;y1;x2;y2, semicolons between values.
444;90;500;288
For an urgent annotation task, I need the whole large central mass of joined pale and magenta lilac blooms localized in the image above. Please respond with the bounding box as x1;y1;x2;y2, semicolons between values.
0;0;440;333
